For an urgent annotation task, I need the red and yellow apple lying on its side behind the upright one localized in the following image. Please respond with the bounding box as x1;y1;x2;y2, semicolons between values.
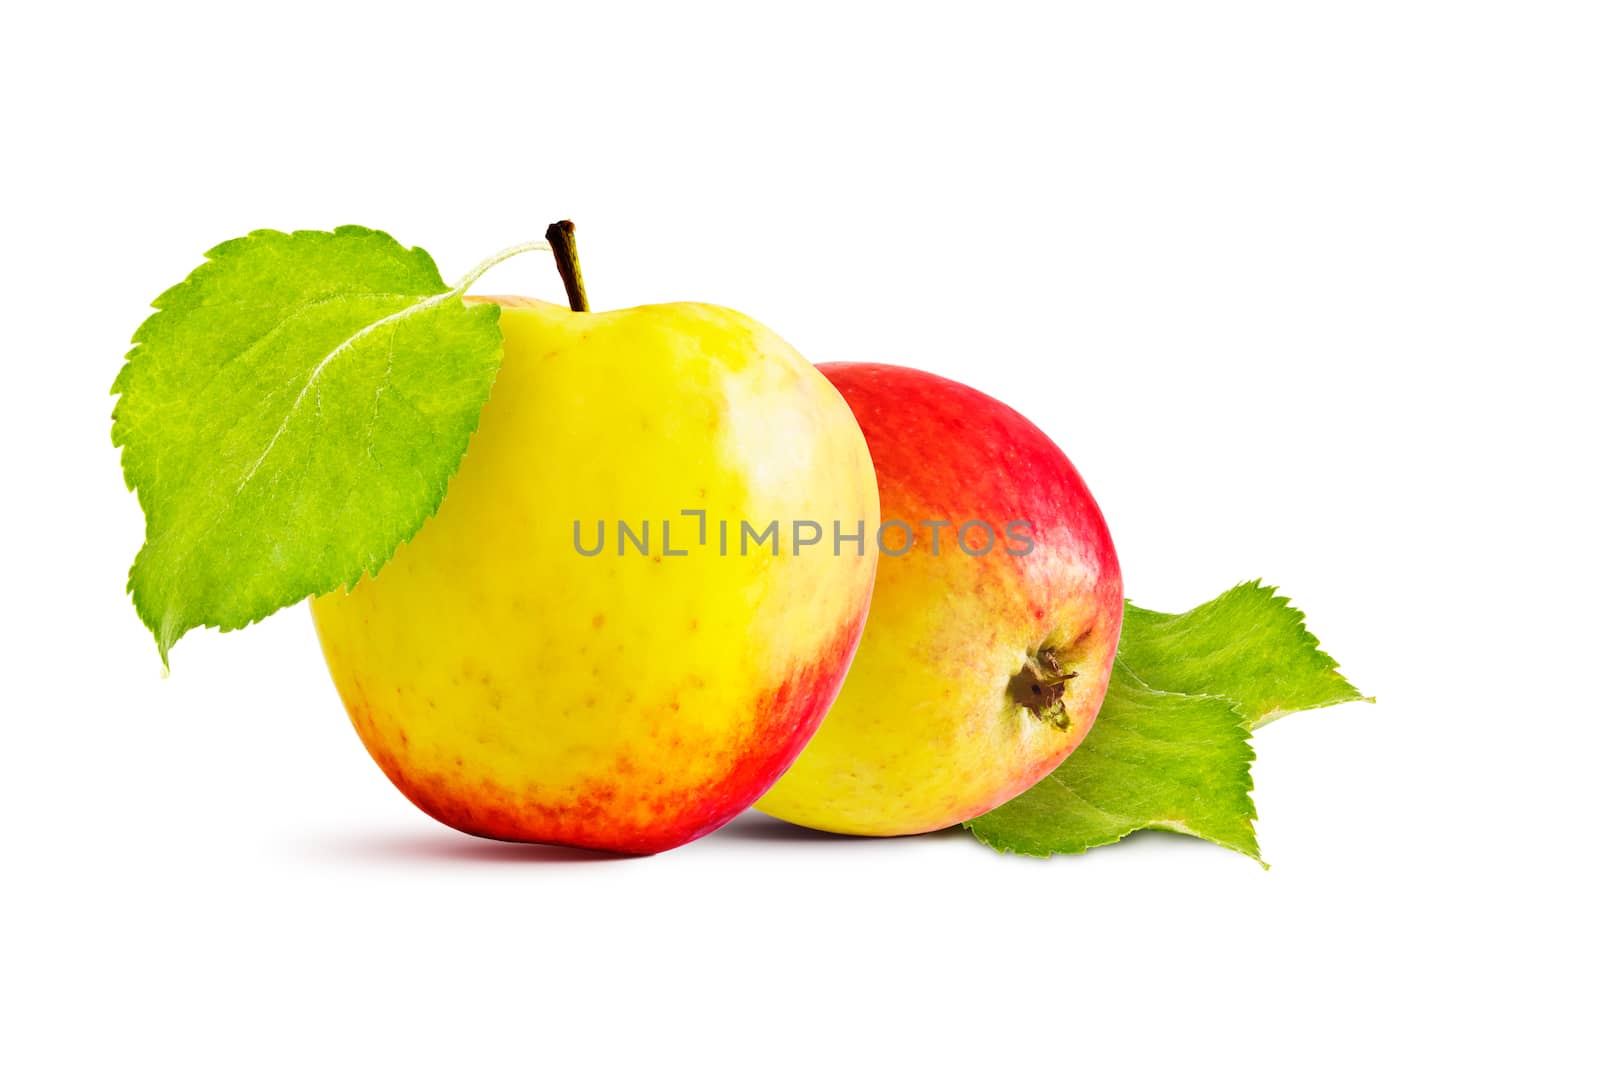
757;363;1123;836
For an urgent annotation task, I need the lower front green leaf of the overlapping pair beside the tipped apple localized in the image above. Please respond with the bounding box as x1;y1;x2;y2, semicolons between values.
966;658;1266;866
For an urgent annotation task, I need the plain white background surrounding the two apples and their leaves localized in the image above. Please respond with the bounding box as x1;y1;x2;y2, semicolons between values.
0;2;1600;1063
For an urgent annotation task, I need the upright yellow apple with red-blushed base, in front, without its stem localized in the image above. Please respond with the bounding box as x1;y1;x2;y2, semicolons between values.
312;298;878;853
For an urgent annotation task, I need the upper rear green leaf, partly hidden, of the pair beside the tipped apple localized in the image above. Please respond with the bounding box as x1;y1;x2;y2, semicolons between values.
1117;581;1365;728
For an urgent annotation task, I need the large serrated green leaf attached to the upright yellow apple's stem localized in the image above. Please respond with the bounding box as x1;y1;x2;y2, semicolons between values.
112;226;508;663
